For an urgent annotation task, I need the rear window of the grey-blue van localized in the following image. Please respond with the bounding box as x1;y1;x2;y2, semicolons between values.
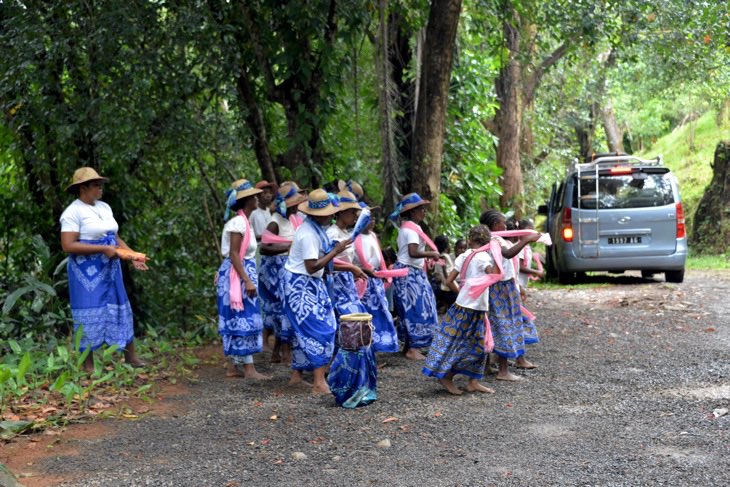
573;172;674;209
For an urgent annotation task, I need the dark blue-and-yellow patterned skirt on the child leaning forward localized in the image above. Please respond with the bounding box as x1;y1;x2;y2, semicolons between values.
423;304;487;379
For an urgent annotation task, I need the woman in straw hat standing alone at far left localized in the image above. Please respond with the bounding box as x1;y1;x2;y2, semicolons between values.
61;167;147;372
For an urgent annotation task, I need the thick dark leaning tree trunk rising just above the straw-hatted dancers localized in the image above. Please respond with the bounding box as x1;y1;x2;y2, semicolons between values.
412;0;461;211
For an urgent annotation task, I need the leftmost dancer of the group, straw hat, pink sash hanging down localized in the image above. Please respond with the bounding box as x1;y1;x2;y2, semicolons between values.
217;179;268;379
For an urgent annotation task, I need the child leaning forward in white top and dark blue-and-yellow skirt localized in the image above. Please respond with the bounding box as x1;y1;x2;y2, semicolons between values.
423;225;497;395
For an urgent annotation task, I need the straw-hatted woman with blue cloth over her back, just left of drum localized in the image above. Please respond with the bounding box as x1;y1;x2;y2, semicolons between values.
284;189;352;394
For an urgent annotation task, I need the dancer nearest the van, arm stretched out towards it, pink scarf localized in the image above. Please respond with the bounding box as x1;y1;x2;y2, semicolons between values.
479;210;540;381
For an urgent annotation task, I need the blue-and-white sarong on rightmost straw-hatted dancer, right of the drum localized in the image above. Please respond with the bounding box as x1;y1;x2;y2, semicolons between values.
393;262;438;349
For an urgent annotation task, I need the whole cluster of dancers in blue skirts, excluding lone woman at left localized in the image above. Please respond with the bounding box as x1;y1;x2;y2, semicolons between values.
216;179;540;407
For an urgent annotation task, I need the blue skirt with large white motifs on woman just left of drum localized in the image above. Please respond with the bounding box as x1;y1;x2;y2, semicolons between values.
284;272;337;370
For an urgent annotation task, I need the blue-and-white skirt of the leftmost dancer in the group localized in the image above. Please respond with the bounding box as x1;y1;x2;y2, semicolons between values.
217;258;264;356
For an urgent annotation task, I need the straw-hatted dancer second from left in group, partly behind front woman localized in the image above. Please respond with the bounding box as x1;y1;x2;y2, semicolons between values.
259;184;307;363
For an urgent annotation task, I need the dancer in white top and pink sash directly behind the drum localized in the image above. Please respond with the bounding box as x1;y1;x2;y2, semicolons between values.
354;210;398;352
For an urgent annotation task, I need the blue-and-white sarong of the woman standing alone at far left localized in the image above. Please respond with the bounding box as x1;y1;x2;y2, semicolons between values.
66;232;134;351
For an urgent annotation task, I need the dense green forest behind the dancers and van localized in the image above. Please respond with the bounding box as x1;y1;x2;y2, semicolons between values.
0;0;730;356
